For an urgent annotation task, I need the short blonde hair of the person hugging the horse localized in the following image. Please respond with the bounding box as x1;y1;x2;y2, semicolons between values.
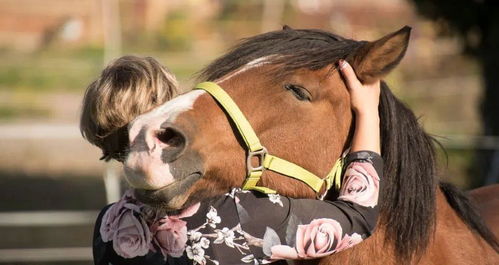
80;56;178;161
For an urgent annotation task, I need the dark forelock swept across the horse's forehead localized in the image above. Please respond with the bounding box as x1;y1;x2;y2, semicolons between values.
200;29;362;81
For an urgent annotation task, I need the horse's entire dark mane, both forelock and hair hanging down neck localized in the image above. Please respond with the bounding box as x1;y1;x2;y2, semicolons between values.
200;29;496;262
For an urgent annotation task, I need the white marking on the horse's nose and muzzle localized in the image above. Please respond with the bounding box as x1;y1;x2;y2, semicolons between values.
125;90;206;190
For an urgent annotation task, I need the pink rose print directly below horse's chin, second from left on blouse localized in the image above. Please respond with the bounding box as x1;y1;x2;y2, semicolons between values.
150;203;200;257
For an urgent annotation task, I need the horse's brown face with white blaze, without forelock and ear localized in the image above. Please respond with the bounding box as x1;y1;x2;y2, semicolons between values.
125;26;410;210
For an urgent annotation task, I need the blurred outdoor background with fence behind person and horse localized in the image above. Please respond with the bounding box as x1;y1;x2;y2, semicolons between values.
0;0;499;264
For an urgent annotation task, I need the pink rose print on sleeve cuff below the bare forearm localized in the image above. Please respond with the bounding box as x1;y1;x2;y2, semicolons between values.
338;162;379;207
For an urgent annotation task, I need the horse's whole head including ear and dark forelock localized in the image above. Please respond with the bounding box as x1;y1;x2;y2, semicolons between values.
125;27;410;210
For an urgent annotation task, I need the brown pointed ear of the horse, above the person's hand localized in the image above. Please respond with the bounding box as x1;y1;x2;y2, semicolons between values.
347;26;411;83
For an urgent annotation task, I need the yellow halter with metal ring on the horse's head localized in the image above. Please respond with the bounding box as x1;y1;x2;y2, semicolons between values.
195;82;343;199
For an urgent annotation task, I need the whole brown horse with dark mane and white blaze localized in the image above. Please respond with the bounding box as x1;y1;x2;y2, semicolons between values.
125;27;499;264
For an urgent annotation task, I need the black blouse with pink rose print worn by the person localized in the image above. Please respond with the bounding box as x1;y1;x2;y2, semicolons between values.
93;151;383;265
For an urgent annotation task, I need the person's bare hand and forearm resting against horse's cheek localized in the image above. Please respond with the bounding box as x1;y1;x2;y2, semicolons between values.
339;60;381;154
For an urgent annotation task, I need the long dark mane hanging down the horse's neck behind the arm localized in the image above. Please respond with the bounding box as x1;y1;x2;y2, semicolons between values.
379;82;437;258
